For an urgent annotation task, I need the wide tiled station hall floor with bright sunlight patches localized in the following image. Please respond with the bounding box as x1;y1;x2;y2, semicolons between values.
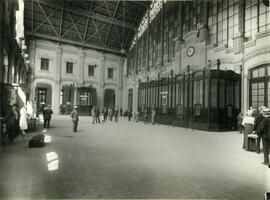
0;116;270;200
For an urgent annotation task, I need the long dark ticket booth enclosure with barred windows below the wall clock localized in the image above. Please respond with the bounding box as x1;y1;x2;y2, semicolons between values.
138;66;241;131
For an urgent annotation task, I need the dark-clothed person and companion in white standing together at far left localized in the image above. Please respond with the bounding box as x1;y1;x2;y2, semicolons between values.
3;104;28;143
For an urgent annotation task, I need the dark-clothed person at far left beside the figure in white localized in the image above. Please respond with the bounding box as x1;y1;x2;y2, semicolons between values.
5;104;20;143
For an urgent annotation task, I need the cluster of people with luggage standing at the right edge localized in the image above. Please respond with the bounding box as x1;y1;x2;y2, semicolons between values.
238;106;270;165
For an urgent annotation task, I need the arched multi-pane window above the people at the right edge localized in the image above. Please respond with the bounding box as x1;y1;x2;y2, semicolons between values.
249;64;270;108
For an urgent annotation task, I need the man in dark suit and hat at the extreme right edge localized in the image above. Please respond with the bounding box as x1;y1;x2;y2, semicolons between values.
262;108;270;165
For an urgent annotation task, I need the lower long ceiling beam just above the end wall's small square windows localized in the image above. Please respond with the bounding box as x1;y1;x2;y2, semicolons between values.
25;31;122;55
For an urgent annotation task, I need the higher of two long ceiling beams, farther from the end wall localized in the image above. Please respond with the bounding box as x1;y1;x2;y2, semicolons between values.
35;0;137;31
